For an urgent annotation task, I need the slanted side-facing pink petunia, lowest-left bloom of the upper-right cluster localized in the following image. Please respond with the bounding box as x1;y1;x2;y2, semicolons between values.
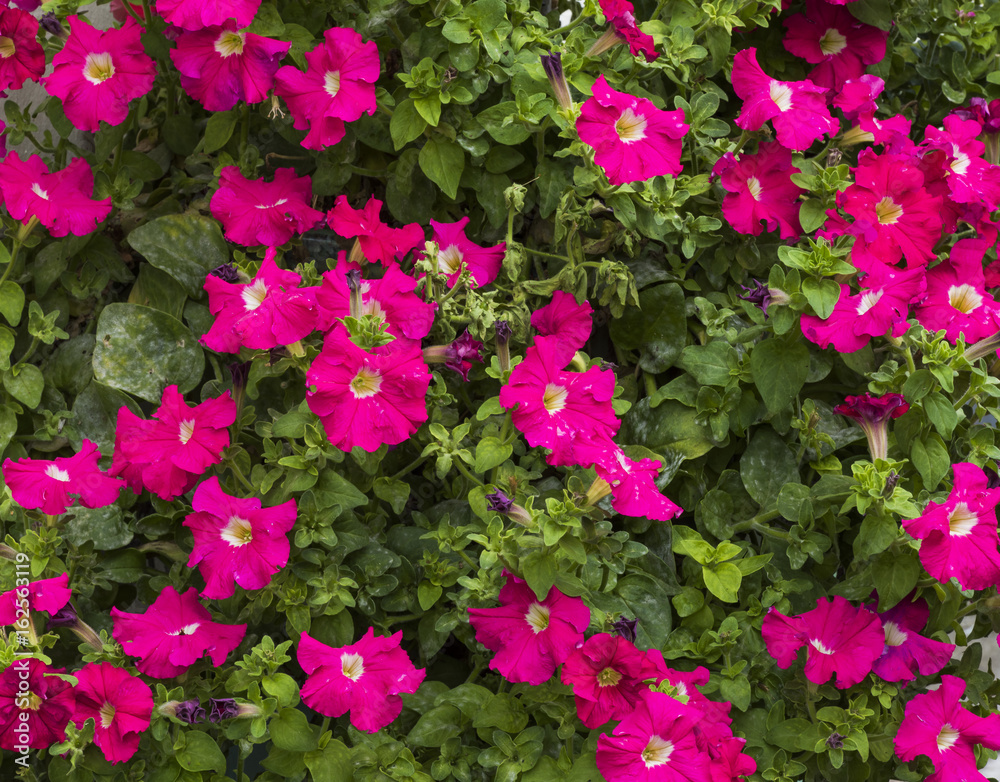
801;267;925;353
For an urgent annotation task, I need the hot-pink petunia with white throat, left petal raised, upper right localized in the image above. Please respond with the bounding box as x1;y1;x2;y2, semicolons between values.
732;49;838;150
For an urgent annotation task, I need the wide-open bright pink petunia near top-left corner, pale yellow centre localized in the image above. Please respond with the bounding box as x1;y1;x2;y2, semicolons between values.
42;15;156;131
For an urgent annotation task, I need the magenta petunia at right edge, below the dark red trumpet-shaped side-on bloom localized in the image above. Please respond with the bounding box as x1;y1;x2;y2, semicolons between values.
902;462;1000;589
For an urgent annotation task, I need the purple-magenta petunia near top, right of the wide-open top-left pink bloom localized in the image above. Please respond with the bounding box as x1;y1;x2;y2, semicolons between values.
170;20;291;111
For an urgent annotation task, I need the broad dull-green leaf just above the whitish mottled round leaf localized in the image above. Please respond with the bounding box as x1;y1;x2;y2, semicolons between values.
128;214;229;299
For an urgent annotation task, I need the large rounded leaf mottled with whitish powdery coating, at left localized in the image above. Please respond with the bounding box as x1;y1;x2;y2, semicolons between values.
94;304;205;402
